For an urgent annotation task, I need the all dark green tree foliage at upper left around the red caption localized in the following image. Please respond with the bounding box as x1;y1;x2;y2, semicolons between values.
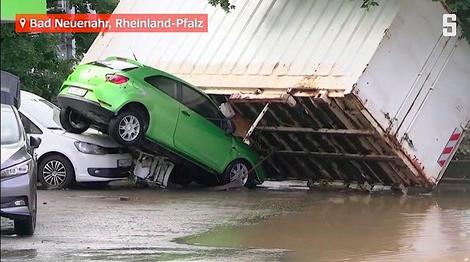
0;0;118;101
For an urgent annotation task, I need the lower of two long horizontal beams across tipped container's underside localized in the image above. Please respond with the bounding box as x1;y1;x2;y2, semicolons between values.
274;150;399;161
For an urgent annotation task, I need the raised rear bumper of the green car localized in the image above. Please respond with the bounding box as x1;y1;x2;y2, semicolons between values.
57;94;114;125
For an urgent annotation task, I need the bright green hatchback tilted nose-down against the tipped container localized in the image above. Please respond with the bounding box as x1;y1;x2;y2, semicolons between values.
57;57;265;187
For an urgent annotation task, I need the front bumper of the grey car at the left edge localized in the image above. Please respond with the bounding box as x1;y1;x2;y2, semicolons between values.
0;174;35;219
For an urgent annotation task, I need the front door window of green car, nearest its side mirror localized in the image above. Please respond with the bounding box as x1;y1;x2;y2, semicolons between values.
181;85;221;126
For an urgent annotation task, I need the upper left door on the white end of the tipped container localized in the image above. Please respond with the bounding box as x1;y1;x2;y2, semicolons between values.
354;0;450;134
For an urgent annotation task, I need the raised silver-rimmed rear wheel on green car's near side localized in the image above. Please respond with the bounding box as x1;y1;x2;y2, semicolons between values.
108;110;147;146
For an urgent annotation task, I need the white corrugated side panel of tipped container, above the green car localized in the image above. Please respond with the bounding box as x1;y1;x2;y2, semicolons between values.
83;0;399;95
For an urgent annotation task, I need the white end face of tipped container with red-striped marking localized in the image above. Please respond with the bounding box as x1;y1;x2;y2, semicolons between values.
355;1;470;183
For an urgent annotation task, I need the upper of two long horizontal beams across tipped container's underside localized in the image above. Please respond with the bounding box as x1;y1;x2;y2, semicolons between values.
256;126;374;136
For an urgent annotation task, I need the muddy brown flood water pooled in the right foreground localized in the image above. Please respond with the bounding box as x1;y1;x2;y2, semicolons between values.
180;188;470;261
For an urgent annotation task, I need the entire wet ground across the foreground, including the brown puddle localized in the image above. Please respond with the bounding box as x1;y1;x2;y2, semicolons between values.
1;182;470;261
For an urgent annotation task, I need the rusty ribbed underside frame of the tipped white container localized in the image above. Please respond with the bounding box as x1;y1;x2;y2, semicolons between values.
209;90;430;189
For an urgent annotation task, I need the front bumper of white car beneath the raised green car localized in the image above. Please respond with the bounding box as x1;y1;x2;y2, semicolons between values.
71;153;132;182
